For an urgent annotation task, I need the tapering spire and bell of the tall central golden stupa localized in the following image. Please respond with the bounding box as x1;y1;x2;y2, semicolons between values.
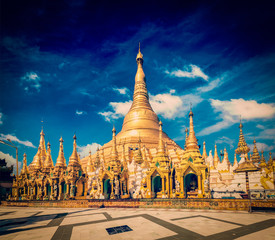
121;44;159;136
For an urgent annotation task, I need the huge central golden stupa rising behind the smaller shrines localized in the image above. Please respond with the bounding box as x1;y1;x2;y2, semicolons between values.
82;44;183;165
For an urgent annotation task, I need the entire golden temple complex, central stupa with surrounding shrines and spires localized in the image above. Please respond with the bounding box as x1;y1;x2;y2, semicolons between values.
11;49;275;199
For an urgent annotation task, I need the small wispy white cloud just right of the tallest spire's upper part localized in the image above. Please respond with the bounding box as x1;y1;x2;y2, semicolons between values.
165;64;209;81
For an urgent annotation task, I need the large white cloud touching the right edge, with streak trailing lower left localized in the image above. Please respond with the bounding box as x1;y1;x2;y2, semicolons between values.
198;98;275;136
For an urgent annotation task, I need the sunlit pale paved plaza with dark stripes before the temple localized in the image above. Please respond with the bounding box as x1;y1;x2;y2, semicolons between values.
0;207;275;240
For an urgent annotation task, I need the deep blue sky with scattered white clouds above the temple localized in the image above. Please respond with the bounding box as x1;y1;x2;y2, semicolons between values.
0;0;275;172
